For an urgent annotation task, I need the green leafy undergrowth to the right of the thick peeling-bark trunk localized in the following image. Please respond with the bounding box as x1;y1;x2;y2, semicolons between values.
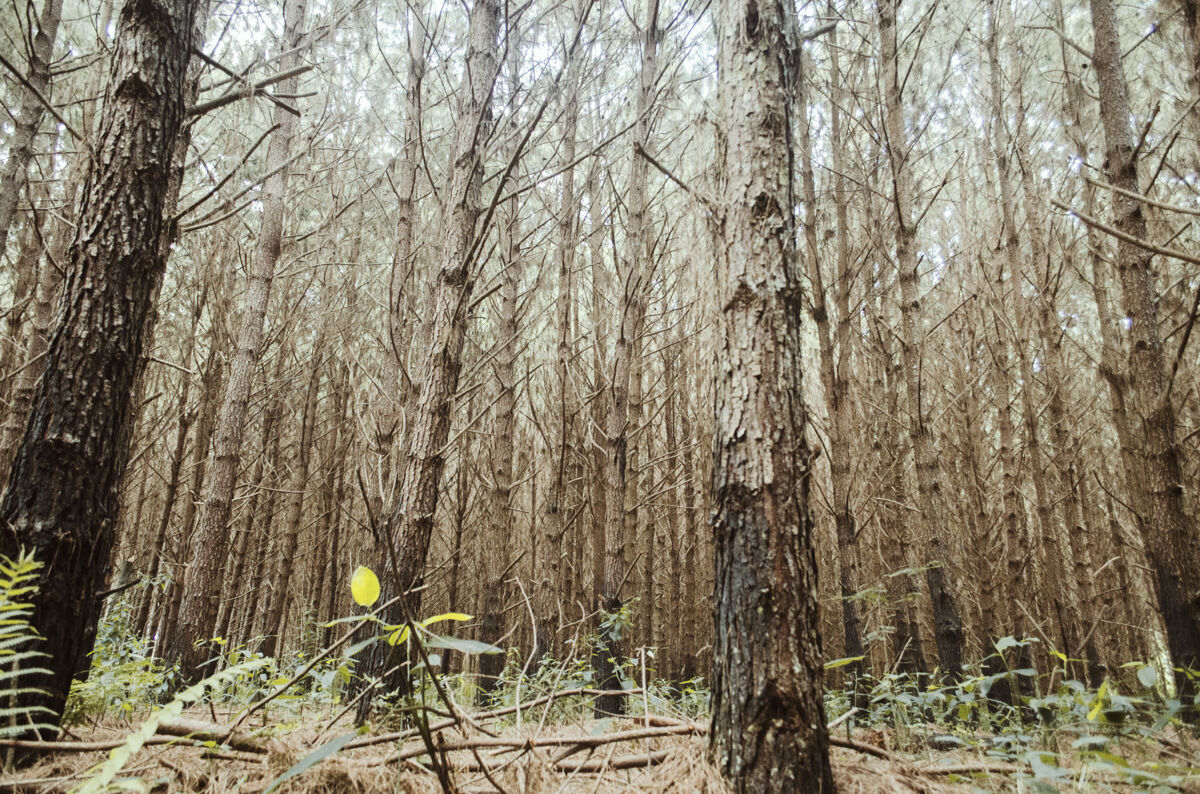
826;638;1200;792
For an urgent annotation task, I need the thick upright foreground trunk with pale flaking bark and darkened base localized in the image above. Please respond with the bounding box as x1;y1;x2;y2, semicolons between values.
710;0;834;792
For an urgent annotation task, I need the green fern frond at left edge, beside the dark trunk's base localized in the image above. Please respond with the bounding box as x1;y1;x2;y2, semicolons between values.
0;551;55;739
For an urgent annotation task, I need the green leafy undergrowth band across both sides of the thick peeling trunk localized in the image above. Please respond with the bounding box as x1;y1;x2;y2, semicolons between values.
14;565;1200;792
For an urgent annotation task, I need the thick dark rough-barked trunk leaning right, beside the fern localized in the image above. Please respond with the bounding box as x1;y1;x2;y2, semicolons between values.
0;0;208;738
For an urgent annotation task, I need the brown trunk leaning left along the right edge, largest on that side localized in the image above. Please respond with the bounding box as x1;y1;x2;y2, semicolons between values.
1091;0;1200;702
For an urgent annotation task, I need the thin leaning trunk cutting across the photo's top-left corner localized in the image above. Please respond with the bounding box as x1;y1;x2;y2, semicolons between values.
0;0;62;257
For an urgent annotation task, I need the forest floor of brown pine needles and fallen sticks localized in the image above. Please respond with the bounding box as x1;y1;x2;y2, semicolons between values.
0;710;1200;794
